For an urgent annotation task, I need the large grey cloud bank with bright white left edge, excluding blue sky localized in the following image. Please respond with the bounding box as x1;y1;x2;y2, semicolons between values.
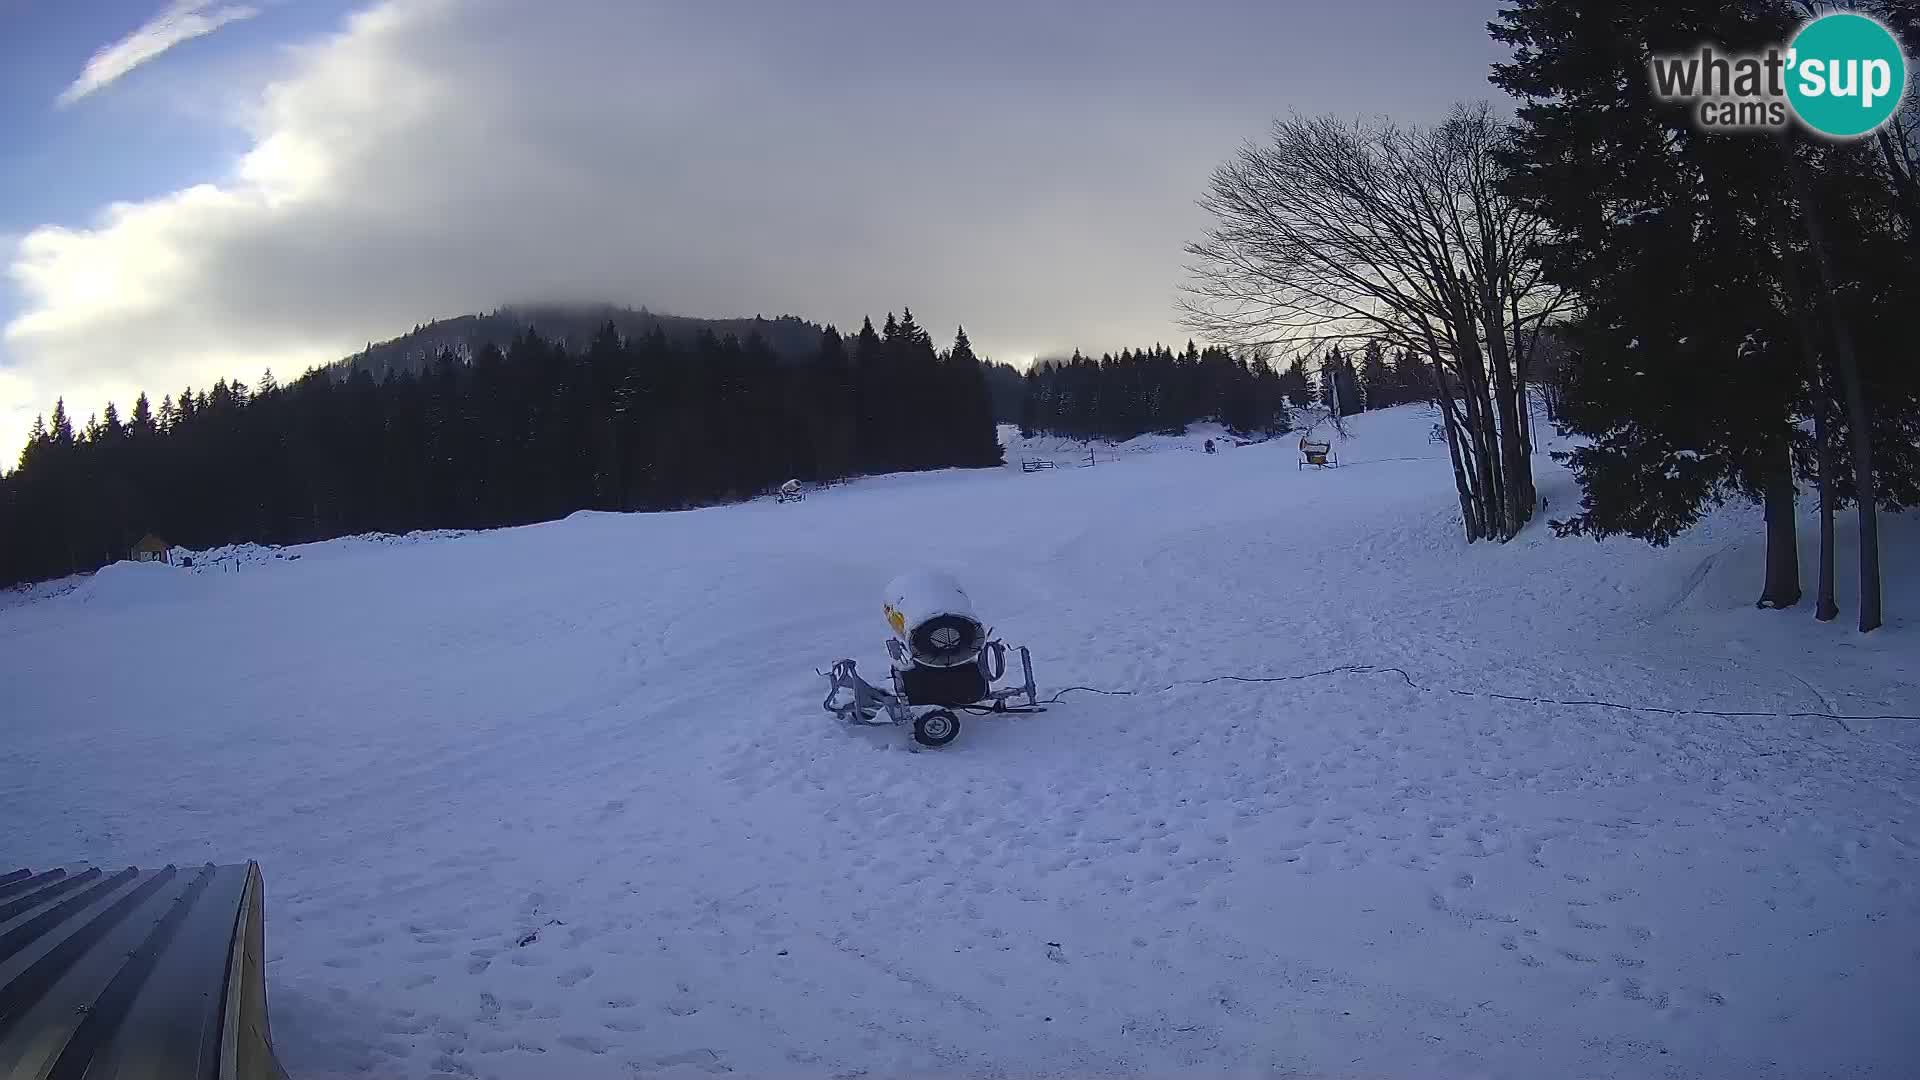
0;0;1480;455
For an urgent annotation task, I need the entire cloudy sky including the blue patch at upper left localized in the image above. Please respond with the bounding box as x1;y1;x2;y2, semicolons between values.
0;0;1500;463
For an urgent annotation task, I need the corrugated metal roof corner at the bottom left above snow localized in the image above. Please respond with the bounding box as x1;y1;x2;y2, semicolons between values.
0;863;284;1080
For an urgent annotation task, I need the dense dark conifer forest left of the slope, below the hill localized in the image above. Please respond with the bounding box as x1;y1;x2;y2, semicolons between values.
0;311;1000;584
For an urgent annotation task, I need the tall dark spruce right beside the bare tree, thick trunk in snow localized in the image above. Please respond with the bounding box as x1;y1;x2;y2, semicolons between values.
1492;0;1803;607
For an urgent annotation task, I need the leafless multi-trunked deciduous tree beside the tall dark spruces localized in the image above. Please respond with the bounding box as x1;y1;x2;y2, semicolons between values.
1185;104;1565;540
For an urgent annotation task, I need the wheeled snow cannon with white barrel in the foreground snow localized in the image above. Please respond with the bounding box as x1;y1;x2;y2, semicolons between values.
820;571;1043;746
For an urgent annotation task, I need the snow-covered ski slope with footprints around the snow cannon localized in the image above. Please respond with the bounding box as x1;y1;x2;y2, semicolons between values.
0;407;1920;1078
